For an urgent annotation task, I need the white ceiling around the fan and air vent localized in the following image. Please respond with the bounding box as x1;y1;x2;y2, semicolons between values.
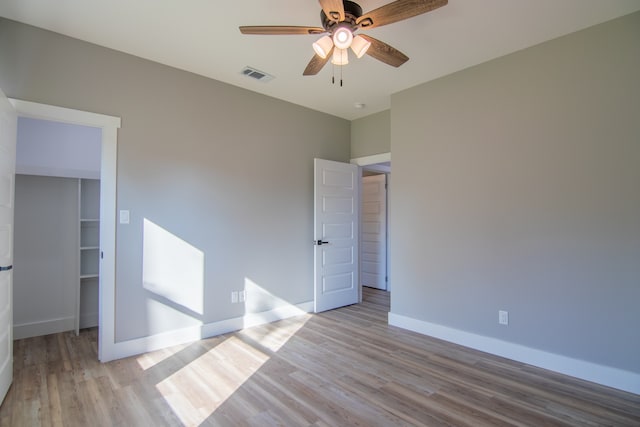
0;0;640;120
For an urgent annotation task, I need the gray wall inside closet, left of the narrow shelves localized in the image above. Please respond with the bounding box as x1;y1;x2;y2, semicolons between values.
13;175;78;338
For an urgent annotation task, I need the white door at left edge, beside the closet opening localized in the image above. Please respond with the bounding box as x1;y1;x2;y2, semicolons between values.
0;91;18;403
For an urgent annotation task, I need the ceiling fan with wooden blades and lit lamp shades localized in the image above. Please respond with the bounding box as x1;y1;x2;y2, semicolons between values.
240;0;448;76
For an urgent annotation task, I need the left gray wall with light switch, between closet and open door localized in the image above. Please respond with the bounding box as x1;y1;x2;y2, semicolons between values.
0;20;350;341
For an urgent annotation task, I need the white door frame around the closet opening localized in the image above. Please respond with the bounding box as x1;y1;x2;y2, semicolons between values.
9;98;121;361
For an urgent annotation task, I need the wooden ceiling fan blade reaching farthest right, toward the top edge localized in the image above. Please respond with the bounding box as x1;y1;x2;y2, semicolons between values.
356;0;448;28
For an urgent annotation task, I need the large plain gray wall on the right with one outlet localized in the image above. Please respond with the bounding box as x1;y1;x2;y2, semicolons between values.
391;13;640;372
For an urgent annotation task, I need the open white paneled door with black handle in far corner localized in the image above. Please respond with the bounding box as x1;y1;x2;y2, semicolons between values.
314;159;360;313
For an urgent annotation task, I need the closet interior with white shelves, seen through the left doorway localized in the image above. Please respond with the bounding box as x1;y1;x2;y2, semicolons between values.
14;118;102;339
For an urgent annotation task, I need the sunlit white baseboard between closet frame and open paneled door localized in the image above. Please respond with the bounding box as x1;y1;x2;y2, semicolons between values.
101;301;313;362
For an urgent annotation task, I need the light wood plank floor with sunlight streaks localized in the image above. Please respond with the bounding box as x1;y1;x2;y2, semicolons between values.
0;289;640;427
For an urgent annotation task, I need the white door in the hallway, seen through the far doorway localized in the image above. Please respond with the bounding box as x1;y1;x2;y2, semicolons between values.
360;174;387;289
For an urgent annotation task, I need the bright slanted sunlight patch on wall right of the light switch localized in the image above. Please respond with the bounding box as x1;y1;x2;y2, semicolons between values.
142;218;204;315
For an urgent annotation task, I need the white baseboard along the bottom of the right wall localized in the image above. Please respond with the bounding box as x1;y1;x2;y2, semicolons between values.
389;313;640;394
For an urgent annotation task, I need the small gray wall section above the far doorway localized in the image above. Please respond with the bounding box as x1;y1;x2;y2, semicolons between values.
351;110;391;159
